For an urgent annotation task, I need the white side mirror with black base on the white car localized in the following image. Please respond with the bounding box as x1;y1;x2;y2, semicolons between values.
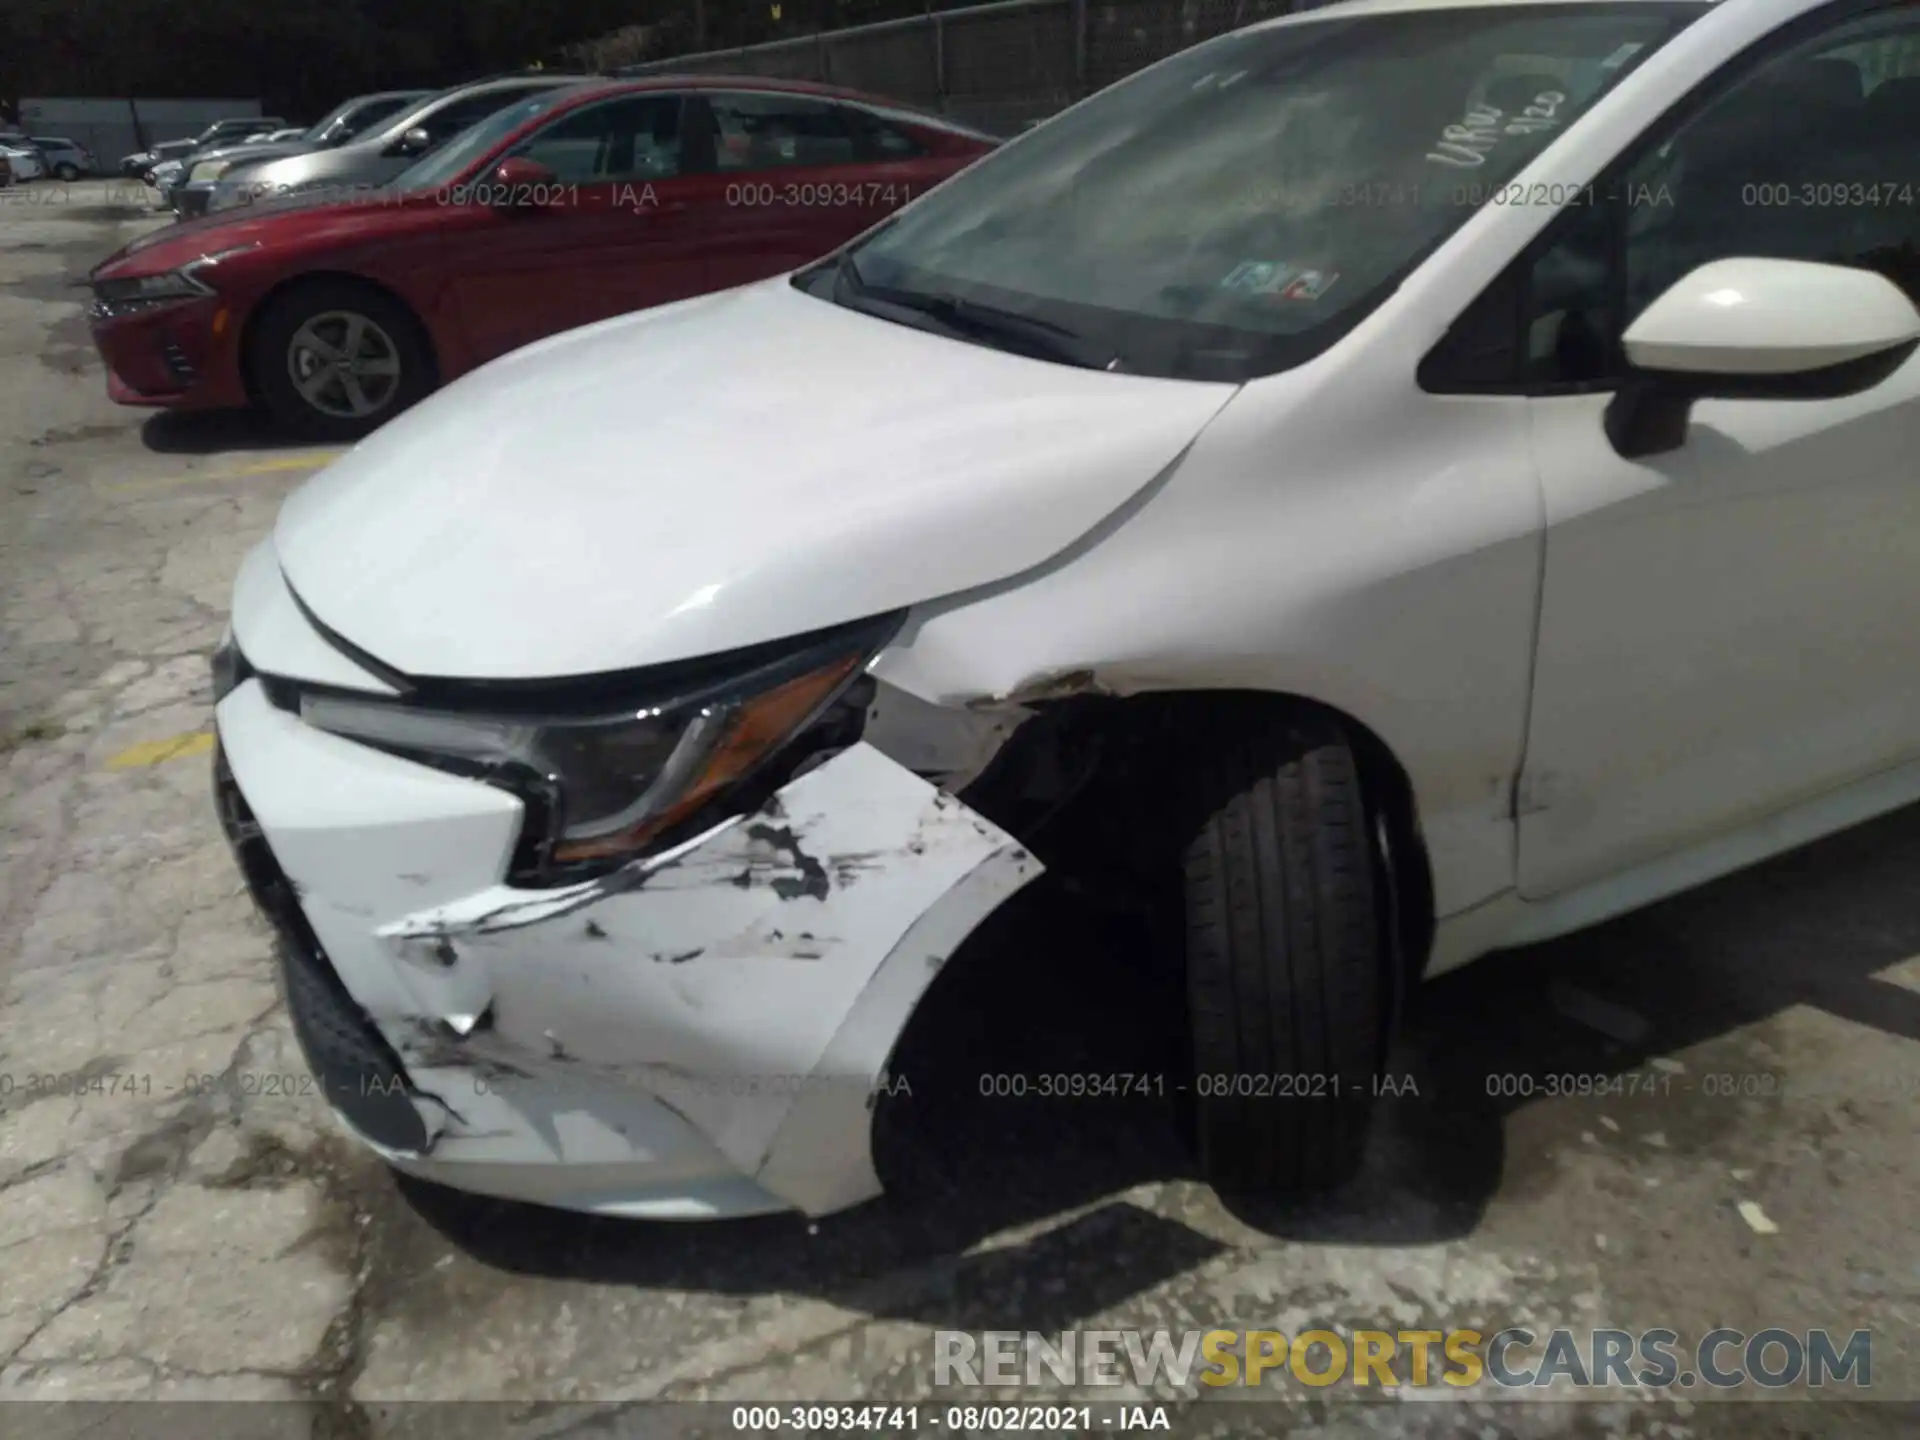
1605;257;1920;459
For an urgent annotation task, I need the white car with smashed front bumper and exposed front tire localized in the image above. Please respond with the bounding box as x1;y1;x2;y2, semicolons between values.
217;0;1920;1217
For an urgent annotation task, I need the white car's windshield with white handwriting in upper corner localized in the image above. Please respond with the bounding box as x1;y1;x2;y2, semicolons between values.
833;0;1705;380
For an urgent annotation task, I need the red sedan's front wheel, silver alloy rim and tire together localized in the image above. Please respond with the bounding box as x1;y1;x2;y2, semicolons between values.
248;280;434;440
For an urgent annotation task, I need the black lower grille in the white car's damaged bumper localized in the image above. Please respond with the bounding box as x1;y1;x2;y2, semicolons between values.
213;747;426;1152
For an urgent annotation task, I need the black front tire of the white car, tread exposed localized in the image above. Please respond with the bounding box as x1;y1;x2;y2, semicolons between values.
1185;712;1394;1194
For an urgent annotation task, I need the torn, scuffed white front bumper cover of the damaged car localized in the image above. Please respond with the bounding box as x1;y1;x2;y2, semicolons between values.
215;680;1041;1217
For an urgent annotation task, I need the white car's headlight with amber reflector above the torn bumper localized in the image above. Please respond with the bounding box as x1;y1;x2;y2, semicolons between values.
300;616;895;866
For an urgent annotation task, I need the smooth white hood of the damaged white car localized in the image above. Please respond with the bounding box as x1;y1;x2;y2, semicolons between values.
275;280;1233;680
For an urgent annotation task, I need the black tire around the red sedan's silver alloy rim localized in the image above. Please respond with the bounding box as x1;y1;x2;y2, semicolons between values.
246;280;438;440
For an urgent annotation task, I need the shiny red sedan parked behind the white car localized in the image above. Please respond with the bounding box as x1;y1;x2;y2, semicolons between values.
90;77;996;438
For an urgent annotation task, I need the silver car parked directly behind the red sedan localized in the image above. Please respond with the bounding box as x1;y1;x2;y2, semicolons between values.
207;73;591;211
